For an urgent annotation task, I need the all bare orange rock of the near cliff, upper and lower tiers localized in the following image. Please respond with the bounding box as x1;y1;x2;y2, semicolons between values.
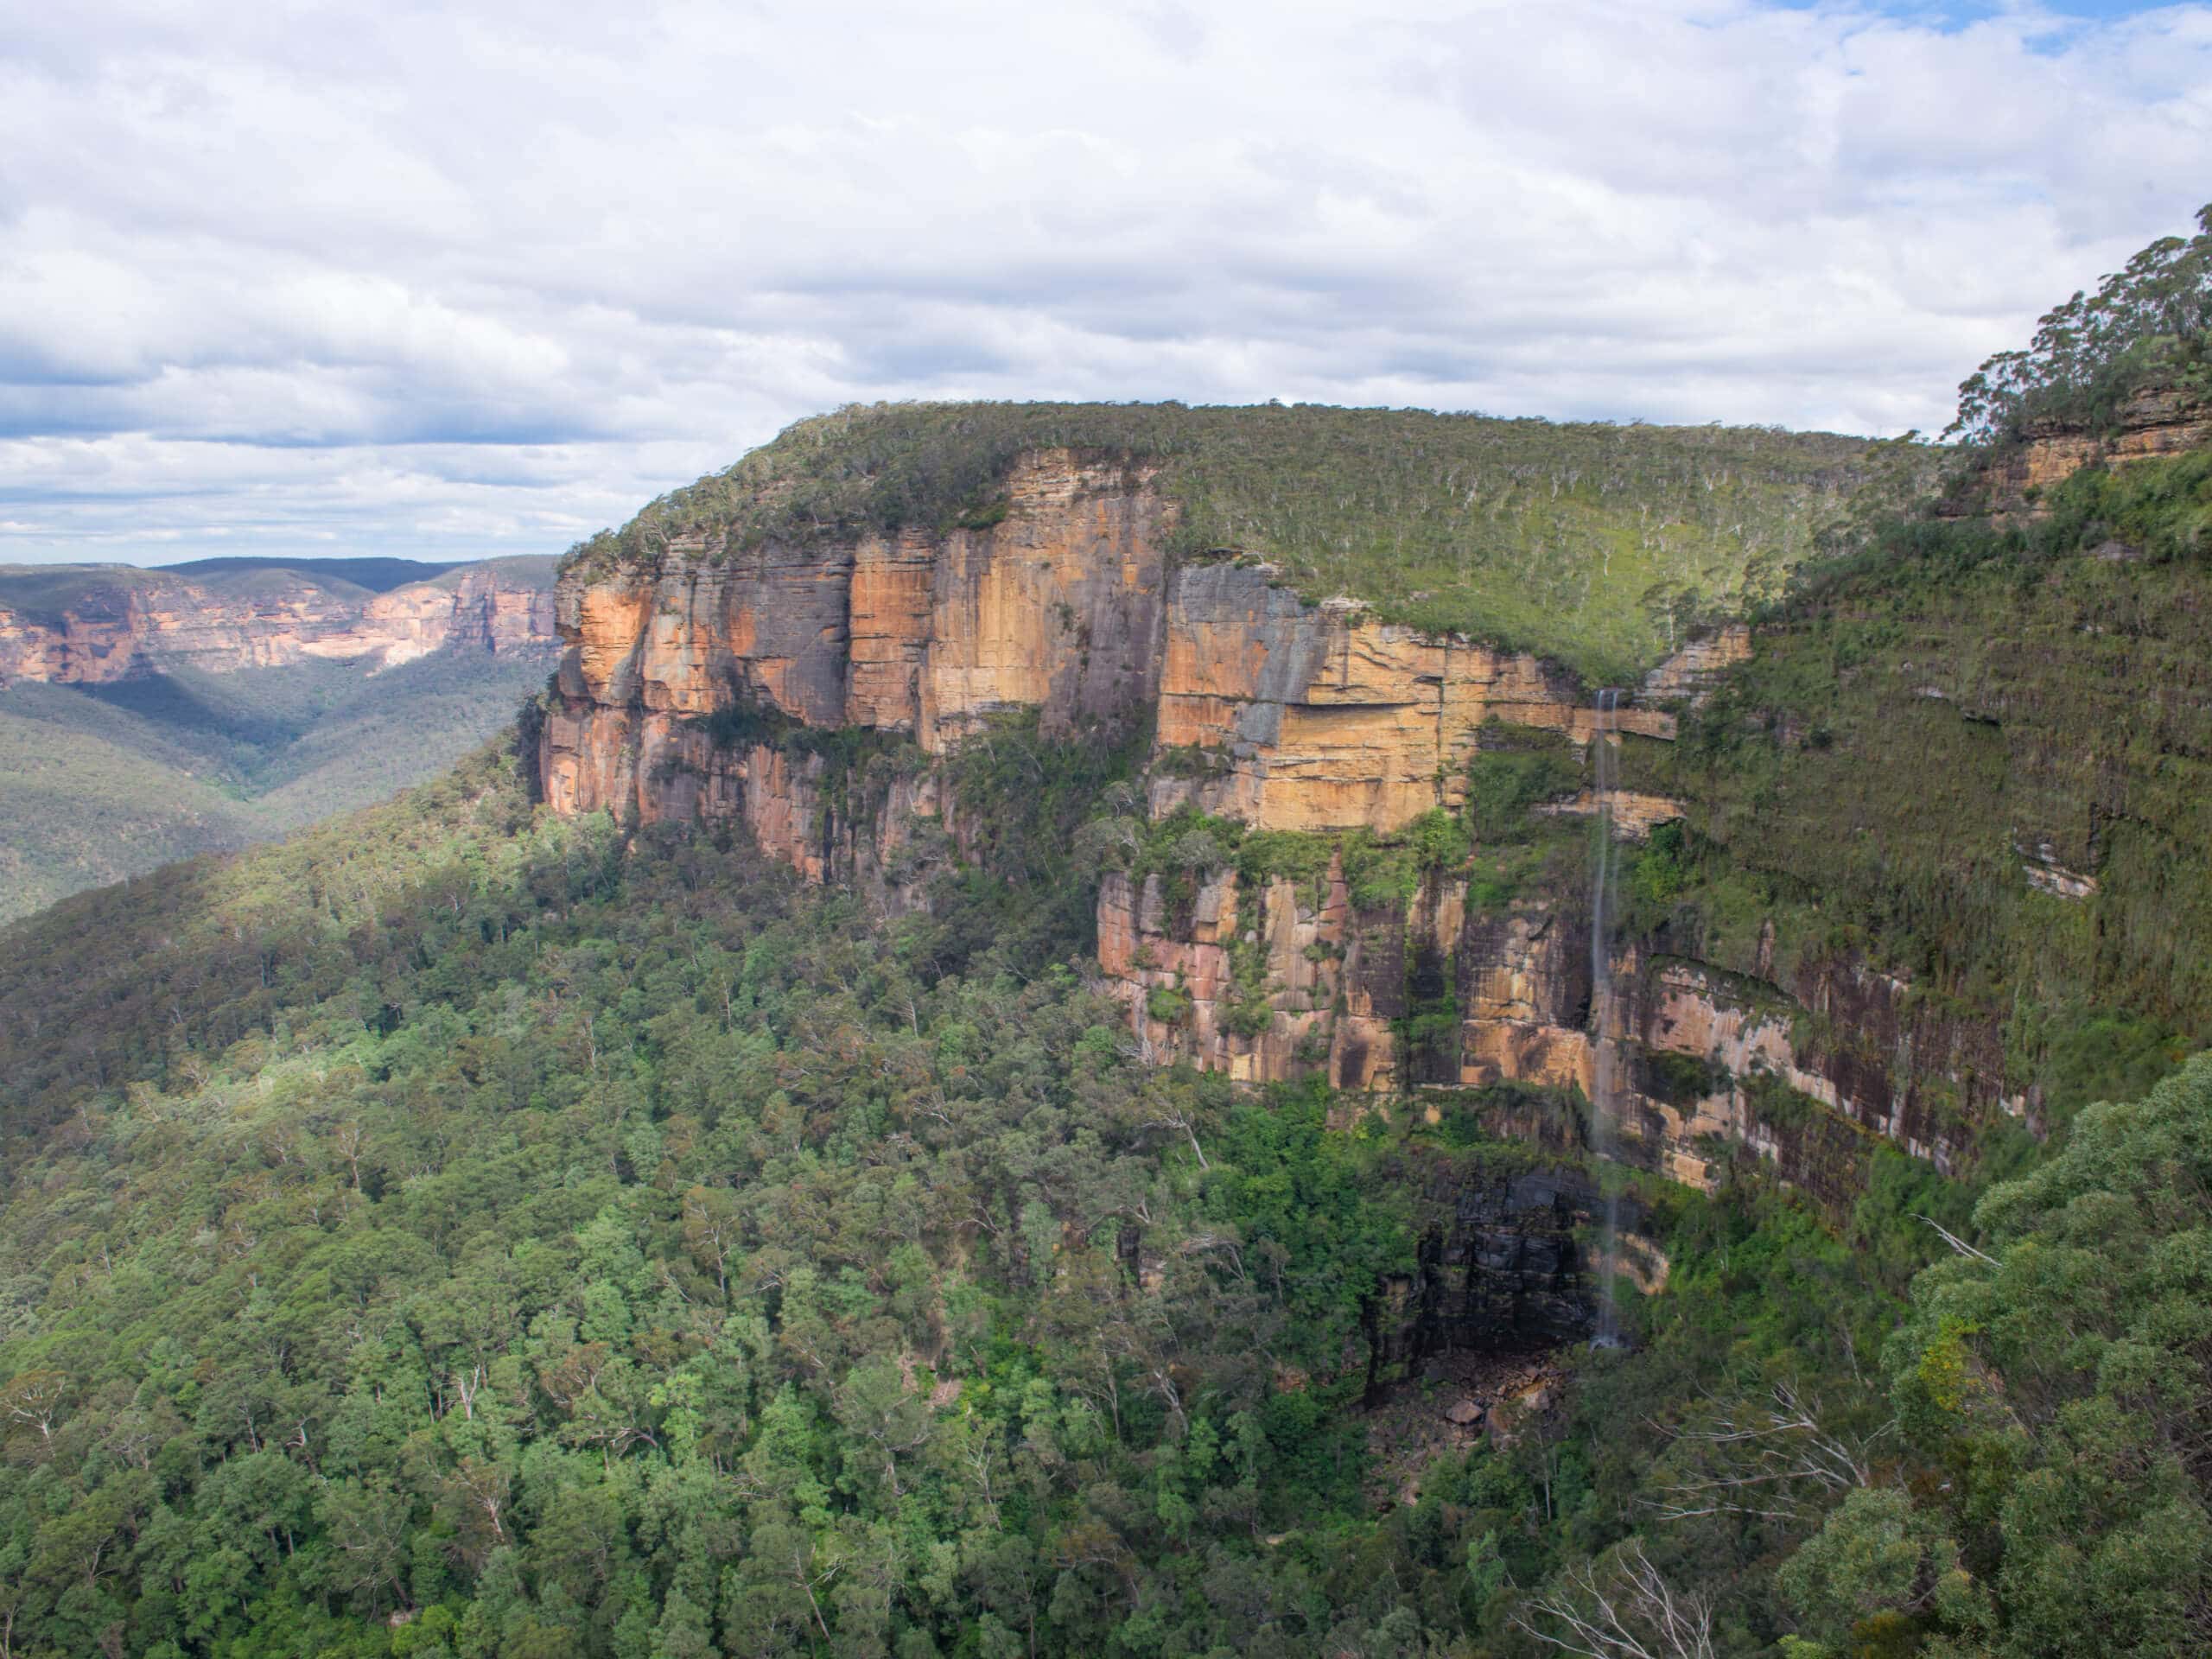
540;451;2002;1192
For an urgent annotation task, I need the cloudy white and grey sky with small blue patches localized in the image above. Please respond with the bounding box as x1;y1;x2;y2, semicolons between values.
0;0;2212;564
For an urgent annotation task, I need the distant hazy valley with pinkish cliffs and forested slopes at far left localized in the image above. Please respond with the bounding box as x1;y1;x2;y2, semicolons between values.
0;557;553;920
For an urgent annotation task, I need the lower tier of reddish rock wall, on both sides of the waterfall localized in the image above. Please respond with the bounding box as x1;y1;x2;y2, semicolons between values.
1099;844;1999;1208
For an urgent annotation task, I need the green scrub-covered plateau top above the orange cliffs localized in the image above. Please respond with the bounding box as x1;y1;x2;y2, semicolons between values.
562;403;1927;681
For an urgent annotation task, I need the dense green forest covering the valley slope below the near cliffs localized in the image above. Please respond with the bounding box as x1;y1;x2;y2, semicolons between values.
0;757;1937;1659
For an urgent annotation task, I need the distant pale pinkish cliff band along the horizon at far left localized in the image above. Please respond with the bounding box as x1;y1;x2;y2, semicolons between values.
0;564;557;686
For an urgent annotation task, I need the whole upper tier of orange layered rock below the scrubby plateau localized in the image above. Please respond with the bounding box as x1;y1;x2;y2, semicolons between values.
540;454;1707;832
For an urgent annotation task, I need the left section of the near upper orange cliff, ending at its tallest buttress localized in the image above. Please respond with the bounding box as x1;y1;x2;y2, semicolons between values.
542;454;1173;827
